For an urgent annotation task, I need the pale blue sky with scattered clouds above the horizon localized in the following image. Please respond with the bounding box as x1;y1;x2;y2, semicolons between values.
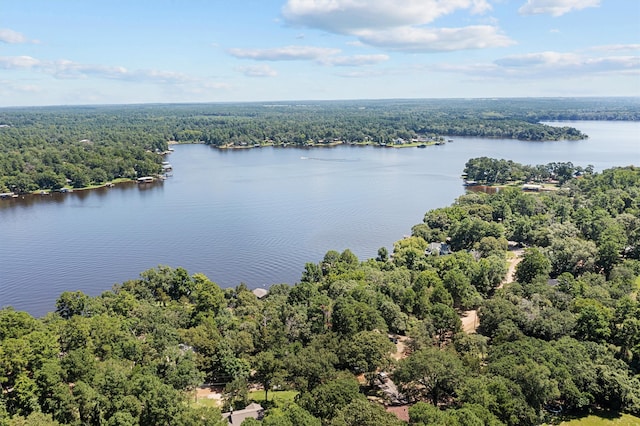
0;0;640;106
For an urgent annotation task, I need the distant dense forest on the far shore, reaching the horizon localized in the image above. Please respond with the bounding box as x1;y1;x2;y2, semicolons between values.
0;98;640;193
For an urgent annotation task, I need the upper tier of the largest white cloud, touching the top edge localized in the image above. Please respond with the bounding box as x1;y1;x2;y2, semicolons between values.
282;0;491;34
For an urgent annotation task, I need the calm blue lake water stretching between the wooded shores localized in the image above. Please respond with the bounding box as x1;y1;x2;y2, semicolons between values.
0;122;640;316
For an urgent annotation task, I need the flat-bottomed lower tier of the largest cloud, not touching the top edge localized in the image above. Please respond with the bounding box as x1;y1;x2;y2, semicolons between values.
358;25;514;52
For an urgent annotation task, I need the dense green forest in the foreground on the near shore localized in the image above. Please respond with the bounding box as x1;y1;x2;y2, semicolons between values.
0;159;640;426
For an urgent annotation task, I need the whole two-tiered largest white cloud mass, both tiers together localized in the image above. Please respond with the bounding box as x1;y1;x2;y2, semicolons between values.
282;0;514;53
